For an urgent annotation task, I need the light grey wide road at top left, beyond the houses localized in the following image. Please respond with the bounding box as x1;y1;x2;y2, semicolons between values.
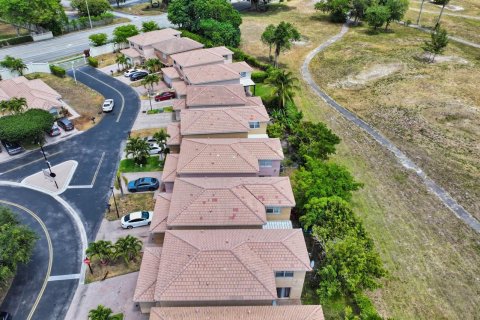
0;13;172;63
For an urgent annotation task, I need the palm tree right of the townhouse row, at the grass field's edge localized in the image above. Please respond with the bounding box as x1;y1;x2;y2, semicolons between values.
265;69;299;108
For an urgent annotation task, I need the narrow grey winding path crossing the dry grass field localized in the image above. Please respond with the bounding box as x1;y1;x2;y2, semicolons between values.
301;23;480;233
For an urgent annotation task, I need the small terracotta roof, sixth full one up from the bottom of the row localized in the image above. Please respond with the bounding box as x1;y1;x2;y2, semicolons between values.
183;64;240;85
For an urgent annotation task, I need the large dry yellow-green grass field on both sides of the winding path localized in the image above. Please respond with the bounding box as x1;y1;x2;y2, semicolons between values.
241;0;480;319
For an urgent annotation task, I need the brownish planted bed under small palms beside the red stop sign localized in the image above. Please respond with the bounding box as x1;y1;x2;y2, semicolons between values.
85;257;142;284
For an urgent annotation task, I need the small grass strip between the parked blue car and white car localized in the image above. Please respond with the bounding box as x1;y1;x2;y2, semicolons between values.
105;193;155;221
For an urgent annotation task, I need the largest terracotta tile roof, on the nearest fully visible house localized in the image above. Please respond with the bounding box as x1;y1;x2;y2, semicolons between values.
153;229;311;301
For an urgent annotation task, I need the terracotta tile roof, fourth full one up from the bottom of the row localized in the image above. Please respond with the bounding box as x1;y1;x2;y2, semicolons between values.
181;107;270;136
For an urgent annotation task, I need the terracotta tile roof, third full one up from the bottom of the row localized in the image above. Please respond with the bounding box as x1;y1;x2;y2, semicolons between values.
177;139;283;174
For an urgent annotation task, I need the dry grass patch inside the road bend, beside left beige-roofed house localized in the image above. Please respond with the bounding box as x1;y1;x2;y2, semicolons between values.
26;73;104;130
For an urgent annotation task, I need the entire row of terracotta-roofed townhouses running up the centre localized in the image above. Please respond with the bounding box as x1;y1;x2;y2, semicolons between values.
125;29;323;320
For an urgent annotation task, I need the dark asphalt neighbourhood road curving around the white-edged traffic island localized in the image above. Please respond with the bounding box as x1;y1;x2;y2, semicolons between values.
0;67;140;320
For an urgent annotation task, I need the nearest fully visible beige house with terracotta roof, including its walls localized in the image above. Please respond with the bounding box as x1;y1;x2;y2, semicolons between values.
133;229;312;313
